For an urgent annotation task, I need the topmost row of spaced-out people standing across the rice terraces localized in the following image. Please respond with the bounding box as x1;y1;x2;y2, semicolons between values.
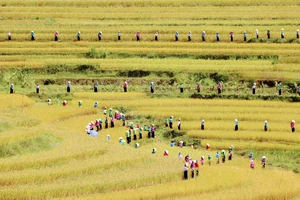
7;28;299;42
